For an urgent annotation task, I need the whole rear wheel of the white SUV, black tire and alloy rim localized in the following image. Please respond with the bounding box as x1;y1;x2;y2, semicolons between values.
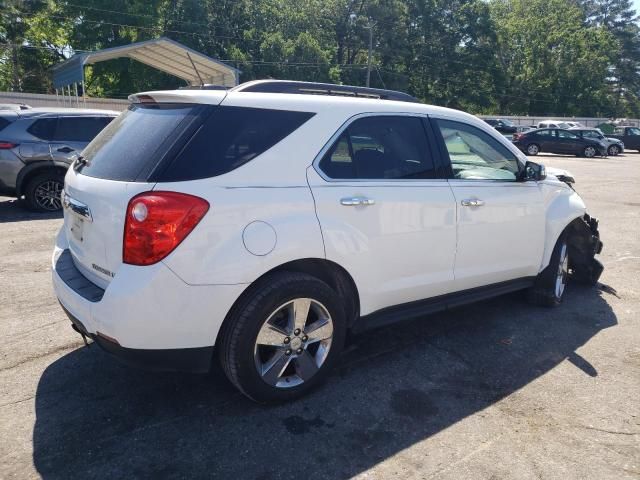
218;272;346;403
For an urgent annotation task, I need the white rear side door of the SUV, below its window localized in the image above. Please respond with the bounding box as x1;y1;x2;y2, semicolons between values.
308;168;456;315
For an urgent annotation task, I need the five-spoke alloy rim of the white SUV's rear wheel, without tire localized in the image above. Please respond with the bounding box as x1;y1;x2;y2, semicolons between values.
254;298;333;388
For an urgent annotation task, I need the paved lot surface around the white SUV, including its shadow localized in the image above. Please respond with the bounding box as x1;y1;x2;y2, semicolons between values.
0;154;640;480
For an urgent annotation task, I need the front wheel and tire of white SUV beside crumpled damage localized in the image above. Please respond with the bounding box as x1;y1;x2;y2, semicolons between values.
527;232;569;307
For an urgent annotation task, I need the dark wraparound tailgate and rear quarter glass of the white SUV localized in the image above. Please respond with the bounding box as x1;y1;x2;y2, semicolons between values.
78;104;313;182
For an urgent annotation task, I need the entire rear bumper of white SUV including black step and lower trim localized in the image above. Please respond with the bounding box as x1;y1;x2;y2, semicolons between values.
52;227;246;371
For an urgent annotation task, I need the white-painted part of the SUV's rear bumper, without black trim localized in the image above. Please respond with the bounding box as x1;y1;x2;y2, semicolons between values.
52;231;246;349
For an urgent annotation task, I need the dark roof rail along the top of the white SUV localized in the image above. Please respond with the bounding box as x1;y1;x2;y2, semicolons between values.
230;80;419;103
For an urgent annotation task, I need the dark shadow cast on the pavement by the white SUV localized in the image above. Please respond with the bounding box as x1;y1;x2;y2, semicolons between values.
33;286;617;479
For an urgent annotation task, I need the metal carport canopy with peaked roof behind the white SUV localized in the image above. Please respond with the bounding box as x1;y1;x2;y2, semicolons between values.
53;37;240;89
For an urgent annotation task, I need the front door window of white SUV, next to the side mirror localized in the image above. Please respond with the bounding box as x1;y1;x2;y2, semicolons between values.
436;119;519;181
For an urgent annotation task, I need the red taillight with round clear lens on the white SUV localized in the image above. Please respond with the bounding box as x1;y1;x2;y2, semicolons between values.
122;192;209;265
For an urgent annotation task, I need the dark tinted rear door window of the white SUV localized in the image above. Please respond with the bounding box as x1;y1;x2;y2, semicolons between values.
320;115;436;180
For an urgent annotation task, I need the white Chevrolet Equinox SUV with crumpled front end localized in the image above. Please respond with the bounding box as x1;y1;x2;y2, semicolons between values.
53;81;602;402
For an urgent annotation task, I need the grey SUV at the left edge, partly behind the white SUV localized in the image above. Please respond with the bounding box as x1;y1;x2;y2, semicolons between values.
0;108;118;212
